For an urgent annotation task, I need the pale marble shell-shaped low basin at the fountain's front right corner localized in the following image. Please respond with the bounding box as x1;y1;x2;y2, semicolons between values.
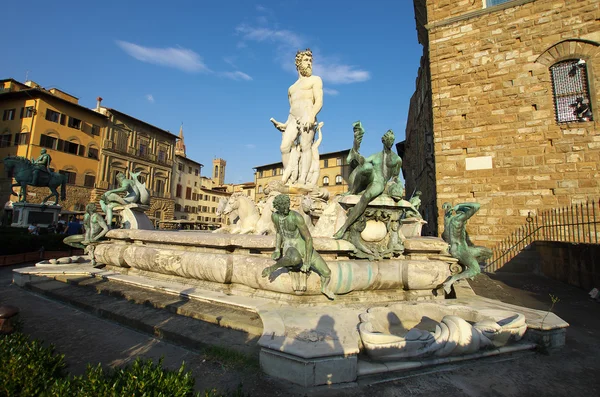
359;302;527;361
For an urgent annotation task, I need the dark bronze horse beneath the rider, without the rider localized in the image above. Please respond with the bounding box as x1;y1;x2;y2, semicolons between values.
3;156;67;205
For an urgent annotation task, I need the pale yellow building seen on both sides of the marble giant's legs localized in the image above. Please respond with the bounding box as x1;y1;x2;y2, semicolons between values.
254;149;350;200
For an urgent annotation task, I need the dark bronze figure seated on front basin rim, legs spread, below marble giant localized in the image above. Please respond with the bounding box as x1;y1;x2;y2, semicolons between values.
262;194;335;300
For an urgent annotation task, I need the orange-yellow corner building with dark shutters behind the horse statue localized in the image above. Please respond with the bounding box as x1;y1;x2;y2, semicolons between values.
0;79;107;211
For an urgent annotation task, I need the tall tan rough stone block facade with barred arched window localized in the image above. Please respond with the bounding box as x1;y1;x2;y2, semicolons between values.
404;0;600;247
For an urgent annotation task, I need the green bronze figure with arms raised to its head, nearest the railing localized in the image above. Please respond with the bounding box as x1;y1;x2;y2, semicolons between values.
442;203;492;294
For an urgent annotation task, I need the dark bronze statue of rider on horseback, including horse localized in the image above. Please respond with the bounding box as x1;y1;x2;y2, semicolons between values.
3;149;67;205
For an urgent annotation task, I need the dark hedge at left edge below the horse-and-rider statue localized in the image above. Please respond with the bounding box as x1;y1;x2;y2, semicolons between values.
0;227;70;255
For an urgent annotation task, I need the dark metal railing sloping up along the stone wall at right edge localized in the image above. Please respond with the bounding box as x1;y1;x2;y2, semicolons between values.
484;200;600;271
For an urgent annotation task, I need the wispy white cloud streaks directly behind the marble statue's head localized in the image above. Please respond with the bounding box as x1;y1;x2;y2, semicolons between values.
236;24;371;84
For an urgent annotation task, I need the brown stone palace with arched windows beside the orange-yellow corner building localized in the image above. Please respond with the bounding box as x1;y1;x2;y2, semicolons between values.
95;98;177;221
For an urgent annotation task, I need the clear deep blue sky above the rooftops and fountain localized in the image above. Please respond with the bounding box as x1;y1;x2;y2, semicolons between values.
0;0;422;183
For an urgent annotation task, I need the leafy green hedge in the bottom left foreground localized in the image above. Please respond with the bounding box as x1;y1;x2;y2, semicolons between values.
0;332;244;397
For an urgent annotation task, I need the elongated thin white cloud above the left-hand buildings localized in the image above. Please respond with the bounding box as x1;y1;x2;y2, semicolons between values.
117;40;210;72
